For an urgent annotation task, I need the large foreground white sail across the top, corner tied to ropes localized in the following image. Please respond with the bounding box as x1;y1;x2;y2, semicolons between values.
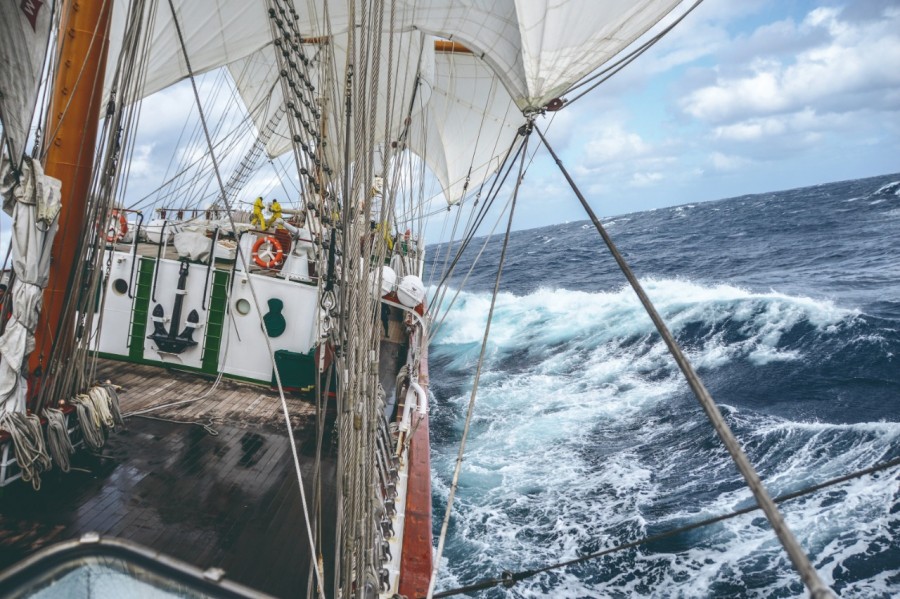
107;0;681;110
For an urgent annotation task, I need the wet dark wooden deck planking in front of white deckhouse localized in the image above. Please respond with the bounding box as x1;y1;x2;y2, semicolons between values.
0;361;336;597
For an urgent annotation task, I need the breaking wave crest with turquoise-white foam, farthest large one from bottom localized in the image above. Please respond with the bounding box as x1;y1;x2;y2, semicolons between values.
434;279;859;371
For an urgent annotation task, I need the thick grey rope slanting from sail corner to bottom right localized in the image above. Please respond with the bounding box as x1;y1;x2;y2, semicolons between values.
534;126;834;599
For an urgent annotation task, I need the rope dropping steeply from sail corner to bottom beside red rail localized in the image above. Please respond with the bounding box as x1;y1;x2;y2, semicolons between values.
428;119;532;599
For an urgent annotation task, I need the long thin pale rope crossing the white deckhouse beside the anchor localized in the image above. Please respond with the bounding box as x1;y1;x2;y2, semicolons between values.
168;0;325;599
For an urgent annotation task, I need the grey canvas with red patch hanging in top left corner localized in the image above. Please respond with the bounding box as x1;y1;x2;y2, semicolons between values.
0;0;53;164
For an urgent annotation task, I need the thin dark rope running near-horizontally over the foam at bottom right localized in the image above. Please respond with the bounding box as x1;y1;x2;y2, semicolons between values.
424;457;900;598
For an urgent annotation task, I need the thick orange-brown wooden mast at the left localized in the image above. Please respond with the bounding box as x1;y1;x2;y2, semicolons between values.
28;0;113;398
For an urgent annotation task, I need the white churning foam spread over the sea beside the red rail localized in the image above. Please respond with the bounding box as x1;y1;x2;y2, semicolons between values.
432;279;900;597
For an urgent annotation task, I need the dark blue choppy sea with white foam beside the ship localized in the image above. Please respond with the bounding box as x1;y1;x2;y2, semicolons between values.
426;174;900;598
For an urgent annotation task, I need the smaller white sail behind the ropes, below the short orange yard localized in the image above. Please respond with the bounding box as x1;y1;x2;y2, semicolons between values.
409;44;525;204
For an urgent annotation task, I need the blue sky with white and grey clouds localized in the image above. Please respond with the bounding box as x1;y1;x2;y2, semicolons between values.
0;0;900;246
